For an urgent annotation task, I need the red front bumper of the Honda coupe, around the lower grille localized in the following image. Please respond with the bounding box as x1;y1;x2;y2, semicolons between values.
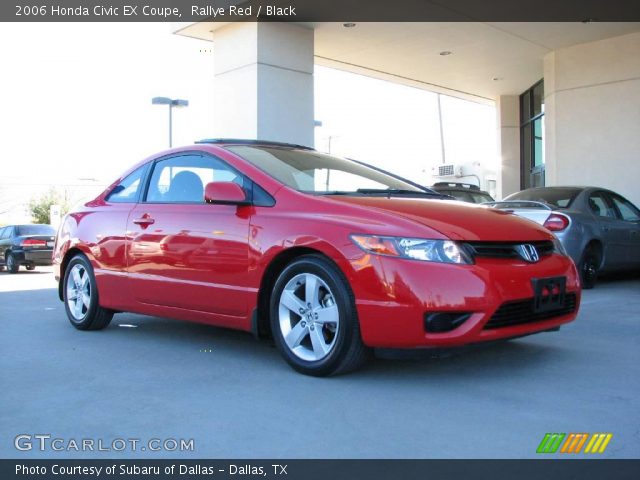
351;254;580;348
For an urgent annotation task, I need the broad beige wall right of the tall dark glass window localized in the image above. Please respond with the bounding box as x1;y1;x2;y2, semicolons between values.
544;33;640;205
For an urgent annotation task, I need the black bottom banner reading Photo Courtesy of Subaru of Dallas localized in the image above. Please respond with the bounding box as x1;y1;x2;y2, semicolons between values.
0;459;640;480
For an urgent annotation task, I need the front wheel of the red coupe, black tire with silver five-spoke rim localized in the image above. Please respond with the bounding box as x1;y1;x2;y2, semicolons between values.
270;255;368;377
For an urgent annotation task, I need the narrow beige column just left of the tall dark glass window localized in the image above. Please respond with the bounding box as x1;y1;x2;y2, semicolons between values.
496;95;520;199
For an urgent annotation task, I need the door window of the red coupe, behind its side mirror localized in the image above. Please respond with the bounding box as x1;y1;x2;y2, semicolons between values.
146;155;243;203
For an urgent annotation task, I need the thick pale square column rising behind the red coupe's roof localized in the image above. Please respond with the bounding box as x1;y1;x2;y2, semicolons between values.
213;22;314;146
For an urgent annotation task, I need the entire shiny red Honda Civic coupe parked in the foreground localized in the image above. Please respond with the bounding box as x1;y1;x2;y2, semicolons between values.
53;139;580;376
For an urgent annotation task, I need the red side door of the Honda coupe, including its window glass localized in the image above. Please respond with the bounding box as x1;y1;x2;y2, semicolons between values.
127;153;251;316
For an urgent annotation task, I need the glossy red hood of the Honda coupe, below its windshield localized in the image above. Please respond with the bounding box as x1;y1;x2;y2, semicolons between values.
326;196;552;241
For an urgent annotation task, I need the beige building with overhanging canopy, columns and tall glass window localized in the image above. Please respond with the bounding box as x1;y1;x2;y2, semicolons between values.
175;22;640;204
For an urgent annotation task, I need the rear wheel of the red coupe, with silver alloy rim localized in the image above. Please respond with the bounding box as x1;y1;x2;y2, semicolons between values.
62;255;113;330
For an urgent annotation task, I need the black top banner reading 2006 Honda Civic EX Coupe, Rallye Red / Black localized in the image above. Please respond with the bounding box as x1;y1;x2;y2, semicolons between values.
0;0;640;23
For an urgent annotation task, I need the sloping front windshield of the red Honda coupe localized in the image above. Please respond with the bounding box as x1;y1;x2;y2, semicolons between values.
226;145;433;195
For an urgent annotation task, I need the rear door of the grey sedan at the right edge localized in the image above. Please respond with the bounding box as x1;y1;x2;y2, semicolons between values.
588;190;628;270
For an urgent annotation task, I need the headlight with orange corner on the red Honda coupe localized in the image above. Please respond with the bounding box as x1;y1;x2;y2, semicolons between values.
351;235;473;264
